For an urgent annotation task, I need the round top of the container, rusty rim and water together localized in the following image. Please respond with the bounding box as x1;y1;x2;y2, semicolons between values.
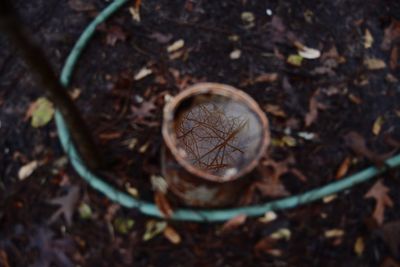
164;85;269;182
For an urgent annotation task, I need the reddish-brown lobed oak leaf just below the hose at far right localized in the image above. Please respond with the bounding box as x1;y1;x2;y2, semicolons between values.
364;180;393;224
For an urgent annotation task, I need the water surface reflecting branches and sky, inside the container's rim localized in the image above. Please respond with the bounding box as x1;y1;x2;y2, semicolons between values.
175;96;262;177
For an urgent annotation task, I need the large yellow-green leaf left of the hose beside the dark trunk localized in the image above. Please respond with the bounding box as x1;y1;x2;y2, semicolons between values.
29;97;54;128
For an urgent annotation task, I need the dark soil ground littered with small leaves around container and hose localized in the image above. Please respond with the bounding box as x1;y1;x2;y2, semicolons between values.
0;0;400;267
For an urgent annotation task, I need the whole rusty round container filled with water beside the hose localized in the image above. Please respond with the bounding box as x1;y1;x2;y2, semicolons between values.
161;83;270;207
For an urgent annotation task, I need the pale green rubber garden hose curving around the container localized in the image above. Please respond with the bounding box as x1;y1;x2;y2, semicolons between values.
55;0;400;222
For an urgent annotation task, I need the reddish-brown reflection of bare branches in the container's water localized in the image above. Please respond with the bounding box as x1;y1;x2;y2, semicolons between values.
176;103;249;174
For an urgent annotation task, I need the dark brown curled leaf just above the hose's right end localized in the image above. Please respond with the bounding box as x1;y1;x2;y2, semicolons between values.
344;132;395;167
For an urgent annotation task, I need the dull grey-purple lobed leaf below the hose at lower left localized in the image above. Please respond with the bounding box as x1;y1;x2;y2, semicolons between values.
48;186;79;226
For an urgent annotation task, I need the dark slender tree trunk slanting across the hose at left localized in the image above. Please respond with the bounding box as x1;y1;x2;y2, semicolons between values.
0;0;101;170
